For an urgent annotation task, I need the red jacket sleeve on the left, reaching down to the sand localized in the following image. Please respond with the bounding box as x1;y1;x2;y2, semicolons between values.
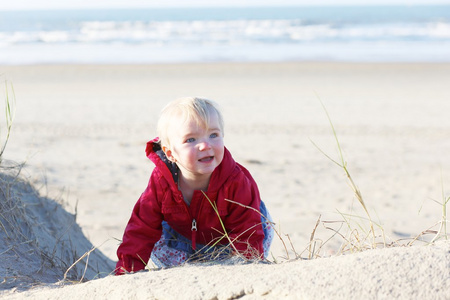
115;172;162;275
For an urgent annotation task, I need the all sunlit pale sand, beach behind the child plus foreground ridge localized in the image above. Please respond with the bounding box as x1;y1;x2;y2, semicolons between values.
0;63;450;299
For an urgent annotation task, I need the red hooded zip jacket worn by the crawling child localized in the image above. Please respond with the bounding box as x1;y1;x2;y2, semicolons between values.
116;139;264;273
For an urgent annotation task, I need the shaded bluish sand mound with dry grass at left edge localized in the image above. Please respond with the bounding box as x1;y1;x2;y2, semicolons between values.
0;82;113;290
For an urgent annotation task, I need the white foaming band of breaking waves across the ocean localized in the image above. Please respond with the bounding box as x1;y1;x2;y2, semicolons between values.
0;20;450;46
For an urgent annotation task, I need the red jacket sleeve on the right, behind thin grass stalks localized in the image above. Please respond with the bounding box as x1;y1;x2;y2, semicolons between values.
225;168;264;258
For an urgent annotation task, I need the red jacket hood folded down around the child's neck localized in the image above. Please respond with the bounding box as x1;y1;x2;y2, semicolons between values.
145;138;239;192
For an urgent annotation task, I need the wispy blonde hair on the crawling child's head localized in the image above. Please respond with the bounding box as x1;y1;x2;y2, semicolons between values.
157;97;224;147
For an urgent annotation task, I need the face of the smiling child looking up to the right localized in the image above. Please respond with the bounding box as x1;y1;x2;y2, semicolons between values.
163;109;224;180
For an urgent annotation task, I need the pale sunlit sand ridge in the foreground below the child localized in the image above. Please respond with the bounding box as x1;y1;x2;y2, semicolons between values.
4;242;450;299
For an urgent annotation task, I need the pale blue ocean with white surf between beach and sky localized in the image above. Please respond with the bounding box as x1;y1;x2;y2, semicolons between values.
0;5;450;65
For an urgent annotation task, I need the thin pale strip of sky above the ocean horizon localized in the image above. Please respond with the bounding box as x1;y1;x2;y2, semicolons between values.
0;0;450;10
